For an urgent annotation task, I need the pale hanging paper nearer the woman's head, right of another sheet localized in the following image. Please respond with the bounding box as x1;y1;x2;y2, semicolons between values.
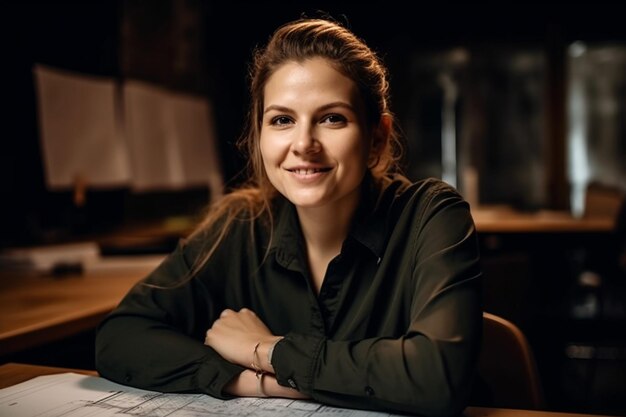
123;80;222;196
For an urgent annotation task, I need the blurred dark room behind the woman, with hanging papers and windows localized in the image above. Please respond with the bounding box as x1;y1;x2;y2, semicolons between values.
0;0;626;415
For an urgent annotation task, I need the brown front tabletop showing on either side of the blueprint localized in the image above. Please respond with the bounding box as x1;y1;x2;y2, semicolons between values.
0;363;616;417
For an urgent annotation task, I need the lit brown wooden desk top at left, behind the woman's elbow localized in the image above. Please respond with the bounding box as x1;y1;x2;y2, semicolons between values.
0;259;158;355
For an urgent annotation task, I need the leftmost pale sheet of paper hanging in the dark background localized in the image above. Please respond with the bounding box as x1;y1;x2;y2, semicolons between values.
33;65;130;189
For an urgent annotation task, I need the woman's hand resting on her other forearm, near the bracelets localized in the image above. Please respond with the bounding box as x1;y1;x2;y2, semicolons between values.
204;308;279;371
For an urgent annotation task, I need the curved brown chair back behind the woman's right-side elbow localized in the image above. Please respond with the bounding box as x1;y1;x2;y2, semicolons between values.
472;312;544;410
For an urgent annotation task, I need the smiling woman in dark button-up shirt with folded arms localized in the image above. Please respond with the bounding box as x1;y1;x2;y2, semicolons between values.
96;19;482;416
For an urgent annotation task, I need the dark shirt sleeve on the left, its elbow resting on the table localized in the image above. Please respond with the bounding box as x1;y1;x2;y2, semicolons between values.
96;239;243;398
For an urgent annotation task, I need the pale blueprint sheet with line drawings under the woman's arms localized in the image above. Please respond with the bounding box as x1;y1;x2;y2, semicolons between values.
0;373;400;417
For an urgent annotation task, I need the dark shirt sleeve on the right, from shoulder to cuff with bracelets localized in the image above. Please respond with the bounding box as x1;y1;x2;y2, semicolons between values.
273;180;482;416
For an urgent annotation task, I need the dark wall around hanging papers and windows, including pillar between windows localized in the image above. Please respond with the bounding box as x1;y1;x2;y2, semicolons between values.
0;0;626;246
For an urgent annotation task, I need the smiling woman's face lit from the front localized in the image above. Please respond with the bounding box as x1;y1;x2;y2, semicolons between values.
260;58;372;213
